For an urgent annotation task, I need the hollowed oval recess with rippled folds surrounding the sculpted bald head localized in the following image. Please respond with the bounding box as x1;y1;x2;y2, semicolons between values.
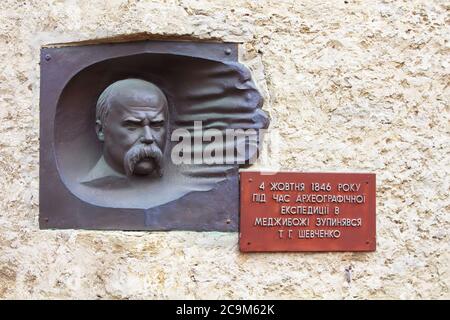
54;53;269;209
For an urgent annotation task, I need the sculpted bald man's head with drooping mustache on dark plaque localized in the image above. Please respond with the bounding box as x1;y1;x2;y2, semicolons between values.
96;79;168;176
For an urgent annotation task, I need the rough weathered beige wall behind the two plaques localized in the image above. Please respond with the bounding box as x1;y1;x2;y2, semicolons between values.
0;0;450;299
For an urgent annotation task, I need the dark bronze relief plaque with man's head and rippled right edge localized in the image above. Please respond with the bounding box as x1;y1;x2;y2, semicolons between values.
39;41;268;231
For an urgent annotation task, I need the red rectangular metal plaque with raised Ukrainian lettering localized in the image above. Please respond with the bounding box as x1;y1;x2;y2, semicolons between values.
239;171;376;252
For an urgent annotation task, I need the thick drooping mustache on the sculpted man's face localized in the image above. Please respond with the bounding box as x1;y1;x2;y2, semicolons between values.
123;143;163;176
